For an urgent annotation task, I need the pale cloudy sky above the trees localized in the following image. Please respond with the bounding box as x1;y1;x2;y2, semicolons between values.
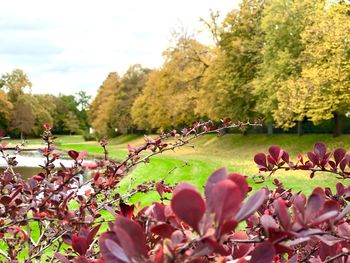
0;0;239;96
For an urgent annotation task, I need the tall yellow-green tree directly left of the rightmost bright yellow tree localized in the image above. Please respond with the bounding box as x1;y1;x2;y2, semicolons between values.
254;0;308;133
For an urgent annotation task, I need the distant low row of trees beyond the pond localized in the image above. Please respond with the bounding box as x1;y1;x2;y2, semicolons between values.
0;69;90;138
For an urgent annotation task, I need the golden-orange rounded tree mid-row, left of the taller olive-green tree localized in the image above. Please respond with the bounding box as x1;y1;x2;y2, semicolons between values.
132;35;211;129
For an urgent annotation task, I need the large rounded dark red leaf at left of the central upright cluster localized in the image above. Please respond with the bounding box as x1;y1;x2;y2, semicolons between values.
171;190;205;233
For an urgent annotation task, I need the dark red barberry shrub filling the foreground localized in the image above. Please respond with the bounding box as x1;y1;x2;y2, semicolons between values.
0;119;350;263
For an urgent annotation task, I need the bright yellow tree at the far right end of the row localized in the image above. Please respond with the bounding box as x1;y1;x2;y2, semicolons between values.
274;0;350;135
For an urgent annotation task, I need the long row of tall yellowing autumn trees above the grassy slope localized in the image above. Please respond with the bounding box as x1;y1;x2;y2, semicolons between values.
90;0;350;134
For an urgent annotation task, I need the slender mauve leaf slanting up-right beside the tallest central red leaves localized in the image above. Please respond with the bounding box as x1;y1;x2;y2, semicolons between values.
235;189;267;222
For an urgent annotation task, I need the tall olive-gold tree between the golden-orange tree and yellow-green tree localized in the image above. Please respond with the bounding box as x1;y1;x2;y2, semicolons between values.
197;0;265;122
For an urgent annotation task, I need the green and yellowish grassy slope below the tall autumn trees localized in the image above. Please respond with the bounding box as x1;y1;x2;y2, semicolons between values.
60;134;350;207
